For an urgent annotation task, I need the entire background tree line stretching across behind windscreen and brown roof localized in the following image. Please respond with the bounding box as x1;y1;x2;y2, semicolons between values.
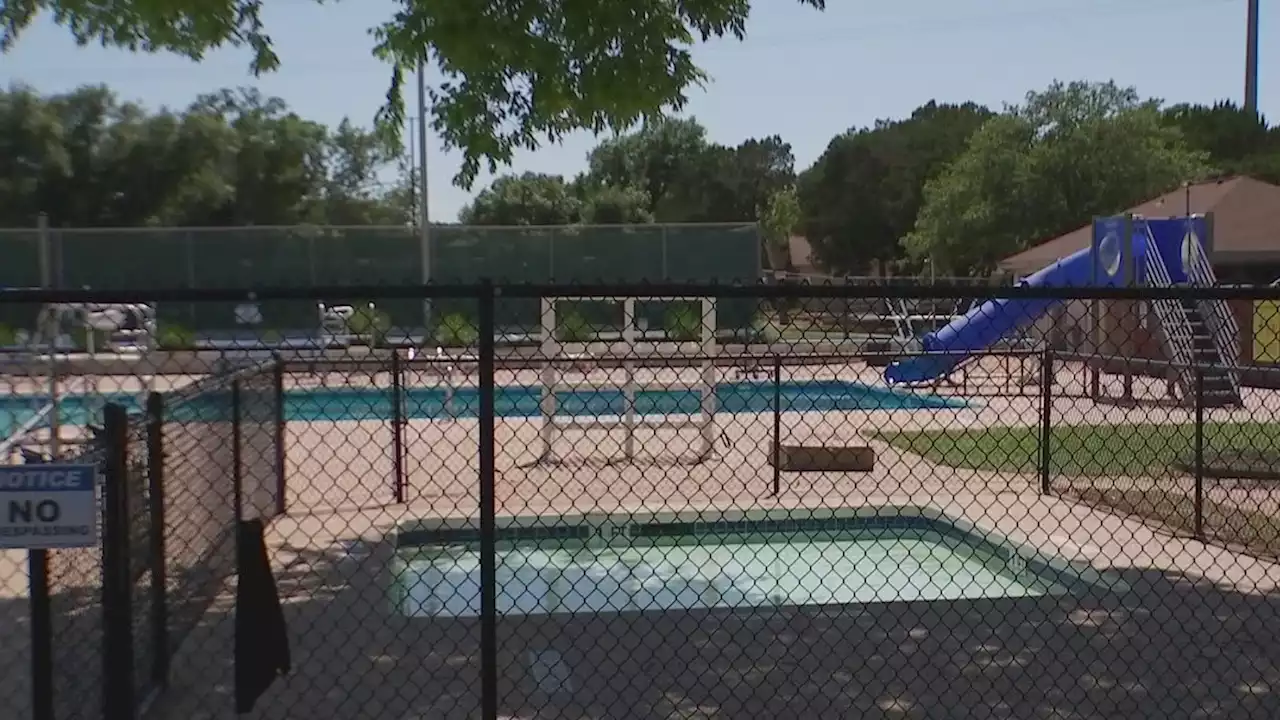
0;82;1280;275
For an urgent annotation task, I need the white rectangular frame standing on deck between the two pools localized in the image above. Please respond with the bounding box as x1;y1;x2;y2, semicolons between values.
538;296;718;462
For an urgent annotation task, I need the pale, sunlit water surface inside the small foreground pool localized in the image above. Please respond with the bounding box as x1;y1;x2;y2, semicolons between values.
393;529;1064;618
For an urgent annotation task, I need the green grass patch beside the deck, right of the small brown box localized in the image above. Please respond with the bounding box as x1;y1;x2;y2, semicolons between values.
876;423;1280;475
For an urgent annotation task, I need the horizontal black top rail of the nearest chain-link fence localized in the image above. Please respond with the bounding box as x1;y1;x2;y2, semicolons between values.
0;281;1280;305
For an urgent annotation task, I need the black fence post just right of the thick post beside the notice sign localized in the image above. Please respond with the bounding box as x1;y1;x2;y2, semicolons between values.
147;392;169;688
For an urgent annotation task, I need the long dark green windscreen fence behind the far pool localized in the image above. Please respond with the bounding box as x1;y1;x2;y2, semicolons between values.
0;223;760;332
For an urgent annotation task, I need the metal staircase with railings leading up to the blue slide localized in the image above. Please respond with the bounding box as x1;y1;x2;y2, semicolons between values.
1146;233;1240;407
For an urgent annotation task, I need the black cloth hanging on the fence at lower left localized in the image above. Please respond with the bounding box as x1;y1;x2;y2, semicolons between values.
236;520;289;714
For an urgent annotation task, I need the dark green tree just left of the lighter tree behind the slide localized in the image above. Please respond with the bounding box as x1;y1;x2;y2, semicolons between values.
799;101;992;274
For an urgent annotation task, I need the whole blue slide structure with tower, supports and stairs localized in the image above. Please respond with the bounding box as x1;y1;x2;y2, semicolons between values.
884;215;1240;406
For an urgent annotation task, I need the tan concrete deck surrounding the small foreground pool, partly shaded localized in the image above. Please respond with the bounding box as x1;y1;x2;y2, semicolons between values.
0;366;1280;720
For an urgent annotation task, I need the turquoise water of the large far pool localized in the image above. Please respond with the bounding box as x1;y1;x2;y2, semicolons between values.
0;380;963;427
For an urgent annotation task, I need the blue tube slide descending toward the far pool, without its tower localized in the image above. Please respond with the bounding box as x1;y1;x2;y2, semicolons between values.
884;231;1146;384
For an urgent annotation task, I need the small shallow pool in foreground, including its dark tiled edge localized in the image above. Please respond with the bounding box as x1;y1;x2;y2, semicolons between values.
392;507;1111;618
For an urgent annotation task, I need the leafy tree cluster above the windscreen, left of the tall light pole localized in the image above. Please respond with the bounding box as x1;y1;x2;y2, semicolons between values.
0;86;408;227
